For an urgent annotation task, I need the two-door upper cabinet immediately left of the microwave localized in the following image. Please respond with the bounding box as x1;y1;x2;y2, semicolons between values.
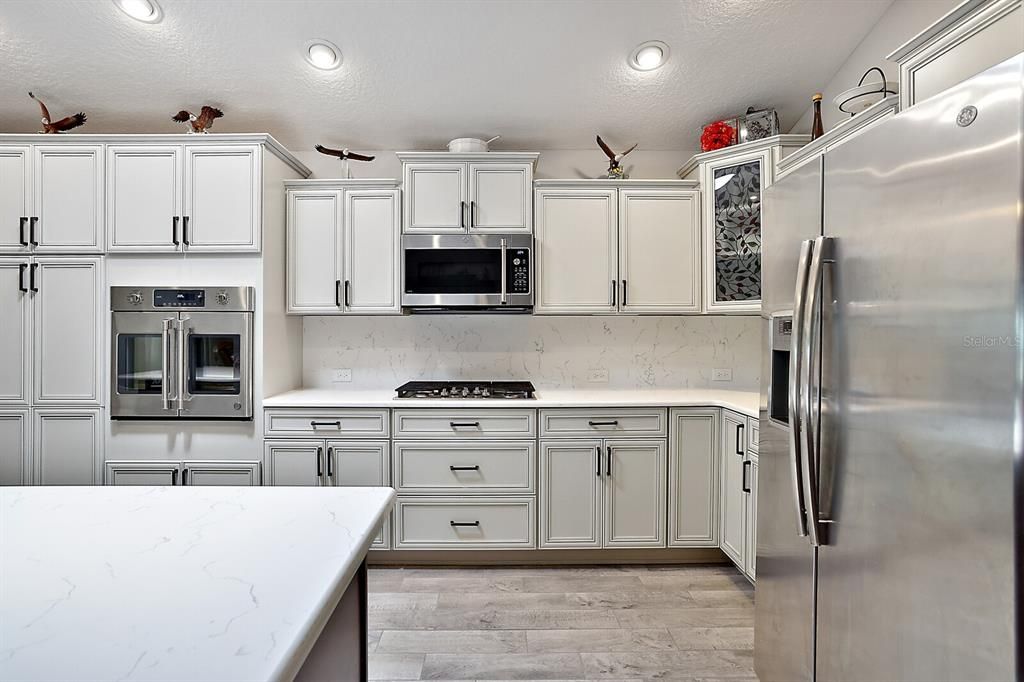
286;180;401;314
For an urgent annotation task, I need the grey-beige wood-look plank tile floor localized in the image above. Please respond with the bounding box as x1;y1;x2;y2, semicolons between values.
370;565;757;682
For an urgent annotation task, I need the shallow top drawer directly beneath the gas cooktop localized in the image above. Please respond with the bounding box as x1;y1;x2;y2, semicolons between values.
394;410;537;439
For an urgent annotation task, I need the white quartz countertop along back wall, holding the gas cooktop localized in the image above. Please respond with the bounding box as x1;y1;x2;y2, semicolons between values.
263;388;760;418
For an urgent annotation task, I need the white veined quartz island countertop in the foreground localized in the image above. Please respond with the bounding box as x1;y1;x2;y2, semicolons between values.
0;486;394;681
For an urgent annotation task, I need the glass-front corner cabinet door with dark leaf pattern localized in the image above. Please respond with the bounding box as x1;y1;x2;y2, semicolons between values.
701;153;769;312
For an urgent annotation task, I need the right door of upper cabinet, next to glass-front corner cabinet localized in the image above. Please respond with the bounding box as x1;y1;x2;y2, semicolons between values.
618;189;700;314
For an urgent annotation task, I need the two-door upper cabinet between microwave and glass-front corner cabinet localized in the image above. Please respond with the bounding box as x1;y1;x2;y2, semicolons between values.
535;180;700;314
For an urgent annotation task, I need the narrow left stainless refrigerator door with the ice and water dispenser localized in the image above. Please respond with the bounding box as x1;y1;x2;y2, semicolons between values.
754;156;821;682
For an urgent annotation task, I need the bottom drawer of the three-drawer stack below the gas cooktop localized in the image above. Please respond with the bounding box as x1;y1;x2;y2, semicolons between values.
394;498;537;549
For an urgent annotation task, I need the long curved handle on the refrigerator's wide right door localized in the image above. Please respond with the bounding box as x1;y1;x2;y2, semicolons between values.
800;237;833;547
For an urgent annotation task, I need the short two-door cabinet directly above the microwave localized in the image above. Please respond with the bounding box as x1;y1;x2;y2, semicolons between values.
398;152;539;233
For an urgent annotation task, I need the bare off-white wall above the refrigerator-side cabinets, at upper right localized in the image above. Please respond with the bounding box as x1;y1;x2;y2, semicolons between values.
792;0;961;133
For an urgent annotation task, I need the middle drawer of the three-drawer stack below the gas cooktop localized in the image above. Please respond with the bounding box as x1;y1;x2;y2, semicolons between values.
394;440;536;495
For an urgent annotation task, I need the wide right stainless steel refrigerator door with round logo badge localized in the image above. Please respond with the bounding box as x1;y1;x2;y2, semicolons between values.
811;56;1024;682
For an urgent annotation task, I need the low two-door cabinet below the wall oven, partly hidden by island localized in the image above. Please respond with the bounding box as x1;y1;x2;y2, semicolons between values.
106;460;260;485
